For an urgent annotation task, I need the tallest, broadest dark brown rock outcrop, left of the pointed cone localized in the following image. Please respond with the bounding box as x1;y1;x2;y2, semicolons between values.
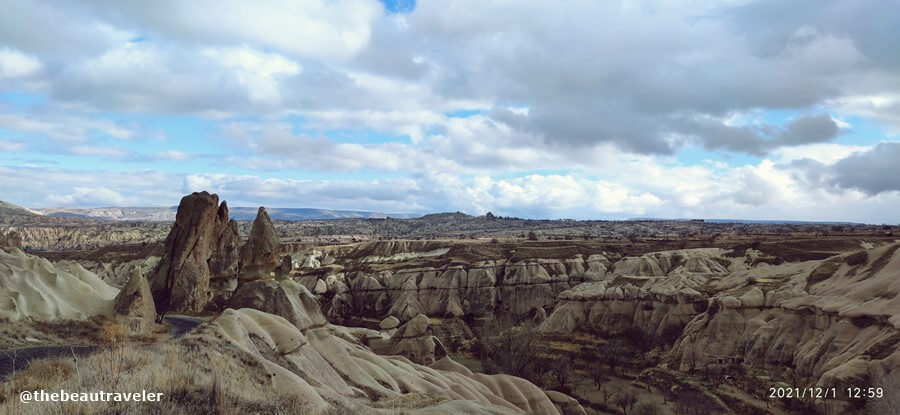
150;192;239;312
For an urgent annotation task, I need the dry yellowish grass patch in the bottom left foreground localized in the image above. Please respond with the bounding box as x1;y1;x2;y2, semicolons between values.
0;340;320;415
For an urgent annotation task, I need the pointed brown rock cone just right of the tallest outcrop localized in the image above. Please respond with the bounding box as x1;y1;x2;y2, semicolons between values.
240;207;282;280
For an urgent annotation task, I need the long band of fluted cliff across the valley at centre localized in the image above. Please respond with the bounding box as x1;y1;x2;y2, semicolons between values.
298;254;608;322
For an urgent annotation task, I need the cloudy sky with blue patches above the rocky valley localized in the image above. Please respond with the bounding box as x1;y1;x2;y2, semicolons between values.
0;0;900;224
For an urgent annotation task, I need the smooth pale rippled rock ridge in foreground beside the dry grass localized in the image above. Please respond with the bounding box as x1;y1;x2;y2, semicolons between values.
186;308;560;415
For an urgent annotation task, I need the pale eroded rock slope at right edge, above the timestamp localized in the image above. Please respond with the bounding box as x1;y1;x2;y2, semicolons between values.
671;244;900;413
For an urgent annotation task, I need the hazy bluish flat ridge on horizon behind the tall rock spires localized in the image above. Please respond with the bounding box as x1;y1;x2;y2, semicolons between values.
30;206;417;222
